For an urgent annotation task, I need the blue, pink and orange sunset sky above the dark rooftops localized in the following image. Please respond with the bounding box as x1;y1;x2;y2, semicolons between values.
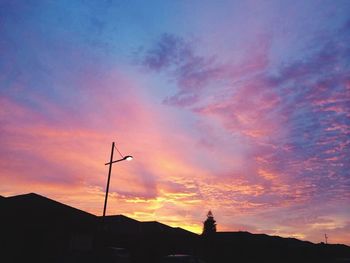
0;0;350;245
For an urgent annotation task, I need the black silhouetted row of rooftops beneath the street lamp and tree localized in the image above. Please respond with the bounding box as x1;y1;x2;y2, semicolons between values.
0;193;350;263
